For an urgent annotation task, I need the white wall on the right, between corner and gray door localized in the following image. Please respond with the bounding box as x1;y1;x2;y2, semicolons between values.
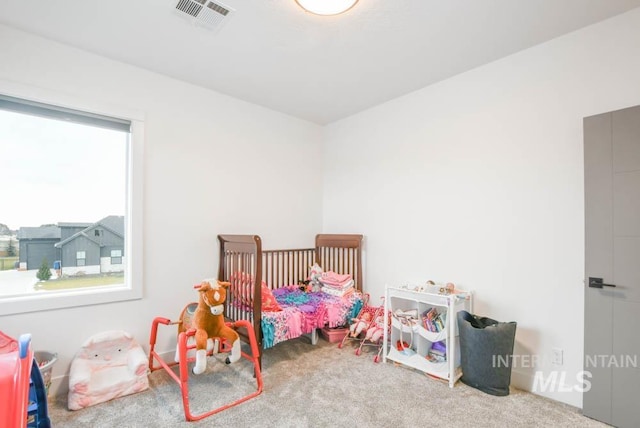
323;9;640;406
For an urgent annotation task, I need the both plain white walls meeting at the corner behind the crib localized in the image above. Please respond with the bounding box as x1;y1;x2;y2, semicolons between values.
5;6;640;406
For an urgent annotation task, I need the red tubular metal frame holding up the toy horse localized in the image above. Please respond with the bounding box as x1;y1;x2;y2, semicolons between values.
149;303;262;421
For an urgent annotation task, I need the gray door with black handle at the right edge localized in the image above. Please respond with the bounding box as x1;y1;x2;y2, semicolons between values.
583;106;640;427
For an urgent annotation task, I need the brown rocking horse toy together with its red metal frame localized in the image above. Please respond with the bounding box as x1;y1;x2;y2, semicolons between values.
149;280;262;421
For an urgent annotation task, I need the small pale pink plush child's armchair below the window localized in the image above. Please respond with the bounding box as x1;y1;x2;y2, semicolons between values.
68;330;149;410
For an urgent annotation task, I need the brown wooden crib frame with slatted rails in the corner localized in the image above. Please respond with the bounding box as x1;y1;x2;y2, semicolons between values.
218;234;363;368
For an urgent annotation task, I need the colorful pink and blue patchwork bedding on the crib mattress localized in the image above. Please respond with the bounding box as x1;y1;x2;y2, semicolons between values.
261;285;362;349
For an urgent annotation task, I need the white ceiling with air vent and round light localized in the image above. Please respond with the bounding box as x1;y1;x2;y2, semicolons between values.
0;0;640;125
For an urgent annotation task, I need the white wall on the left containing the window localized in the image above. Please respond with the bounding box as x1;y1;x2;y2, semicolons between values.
0;26;322;393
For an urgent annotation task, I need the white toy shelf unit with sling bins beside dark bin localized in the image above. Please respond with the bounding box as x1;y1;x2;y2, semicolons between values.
383;286;473;388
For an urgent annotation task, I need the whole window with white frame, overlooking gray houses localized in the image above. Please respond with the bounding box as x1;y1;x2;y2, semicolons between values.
0;85;144;314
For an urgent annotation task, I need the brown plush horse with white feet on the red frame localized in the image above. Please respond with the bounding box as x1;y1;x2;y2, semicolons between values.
181;280;241;374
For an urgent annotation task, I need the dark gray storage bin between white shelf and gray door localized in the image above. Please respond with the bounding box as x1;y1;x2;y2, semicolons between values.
457;311;516;396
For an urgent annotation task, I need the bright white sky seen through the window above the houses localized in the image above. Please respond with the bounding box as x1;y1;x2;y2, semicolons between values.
0;110;128;230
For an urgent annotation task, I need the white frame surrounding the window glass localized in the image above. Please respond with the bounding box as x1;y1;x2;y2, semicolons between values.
0;79;145;315
